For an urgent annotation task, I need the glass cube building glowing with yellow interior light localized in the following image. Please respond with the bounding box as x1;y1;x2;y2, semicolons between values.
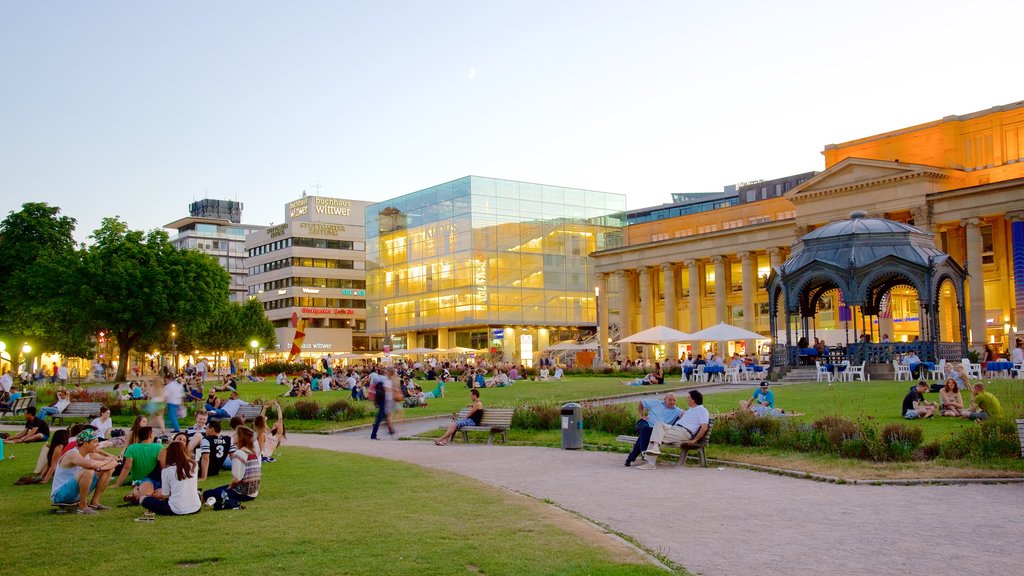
366;176;626;364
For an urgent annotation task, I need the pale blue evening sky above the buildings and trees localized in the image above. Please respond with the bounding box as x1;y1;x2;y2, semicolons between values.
0;0;1024;241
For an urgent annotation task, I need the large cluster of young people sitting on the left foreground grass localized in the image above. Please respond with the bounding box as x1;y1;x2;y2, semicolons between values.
4;376;286;515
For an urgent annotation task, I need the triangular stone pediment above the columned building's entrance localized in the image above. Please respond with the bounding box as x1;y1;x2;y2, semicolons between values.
785;158;949;203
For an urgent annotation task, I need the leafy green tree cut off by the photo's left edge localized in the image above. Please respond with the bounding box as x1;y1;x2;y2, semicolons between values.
0;202;78;366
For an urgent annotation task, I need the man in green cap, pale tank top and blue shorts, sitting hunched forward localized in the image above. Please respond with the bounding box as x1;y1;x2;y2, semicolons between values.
50;428;117;515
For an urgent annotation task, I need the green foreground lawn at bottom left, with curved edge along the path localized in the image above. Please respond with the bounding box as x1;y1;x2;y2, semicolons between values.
0;444;664;576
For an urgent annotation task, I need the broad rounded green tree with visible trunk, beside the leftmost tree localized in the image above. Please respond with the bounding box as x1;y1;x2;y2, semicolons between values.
79;217;229;380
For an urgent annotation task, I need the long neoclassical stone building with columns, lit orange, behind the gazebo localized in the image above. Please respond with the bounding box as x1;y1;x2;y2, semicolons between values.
592;101;1024;359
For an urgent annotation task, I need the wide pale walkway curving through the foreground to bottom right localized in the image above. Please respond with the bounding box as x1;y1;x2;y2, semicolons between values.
286;430;1024;576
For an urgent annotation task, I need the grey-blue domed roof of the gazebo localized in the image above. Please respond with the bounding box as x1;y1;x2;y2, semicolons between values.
779;211;948;275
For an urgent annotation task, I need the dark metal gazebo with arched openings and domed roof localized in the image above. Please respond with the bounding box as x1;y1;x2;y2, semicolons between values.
767;211;967;365
